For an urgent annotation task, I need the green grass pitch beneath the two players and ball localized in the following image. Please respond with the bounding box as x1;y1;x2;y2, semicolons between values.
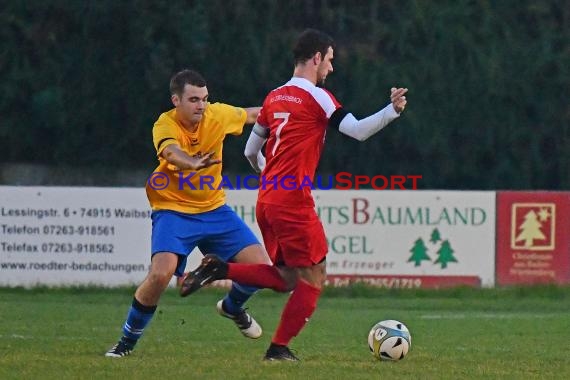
0;286;570;380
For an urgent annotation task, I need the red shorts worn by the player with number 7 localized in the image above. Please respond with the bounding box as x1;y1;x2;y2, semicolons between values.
256;203;328;267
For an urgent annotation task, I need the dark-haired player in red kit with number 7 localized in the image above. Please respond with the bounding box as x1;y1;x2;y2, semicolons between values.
181;29;408;361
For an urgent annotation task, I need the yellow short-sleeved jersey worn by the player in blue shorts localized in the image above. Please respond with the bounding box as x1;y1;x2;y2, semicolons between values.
146;103;247;214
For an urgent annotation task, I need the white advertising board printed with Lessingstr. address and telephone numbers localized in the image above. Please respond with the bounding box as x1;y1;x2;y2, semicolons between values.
0;186;151;286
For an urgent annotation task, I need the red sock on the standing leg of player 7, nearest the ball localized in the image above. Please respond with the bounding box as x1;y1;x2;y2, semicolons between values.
272;280;321;346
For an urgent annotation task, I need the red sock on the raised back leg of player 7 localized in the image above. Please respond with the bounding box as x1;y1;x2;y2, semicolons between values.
227;263;287;292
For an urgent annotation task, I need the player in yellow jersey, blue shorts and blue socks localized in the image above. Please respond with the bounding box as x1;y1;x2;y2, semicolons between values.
105;70;271;357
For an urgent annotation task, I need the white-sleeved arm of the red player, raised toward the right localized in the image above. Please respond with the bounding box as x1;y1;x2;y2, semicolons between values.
336;87;408;141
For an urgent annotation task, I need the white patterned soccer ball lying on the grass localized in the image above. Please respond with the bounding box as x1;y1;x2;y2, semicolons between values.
368;319;412;361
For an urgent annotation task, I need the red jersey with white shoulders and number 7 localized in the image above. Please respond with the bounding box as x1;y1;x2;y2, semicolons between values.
257;77;341;207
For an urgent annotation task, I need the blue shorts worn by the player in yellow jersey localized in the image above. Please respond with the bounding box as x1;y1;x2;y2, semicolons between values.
151;205;259;277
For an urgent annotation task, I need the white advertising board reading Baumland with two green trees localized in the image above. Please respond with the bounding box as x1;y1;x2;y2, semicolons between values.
315;190;495;287
